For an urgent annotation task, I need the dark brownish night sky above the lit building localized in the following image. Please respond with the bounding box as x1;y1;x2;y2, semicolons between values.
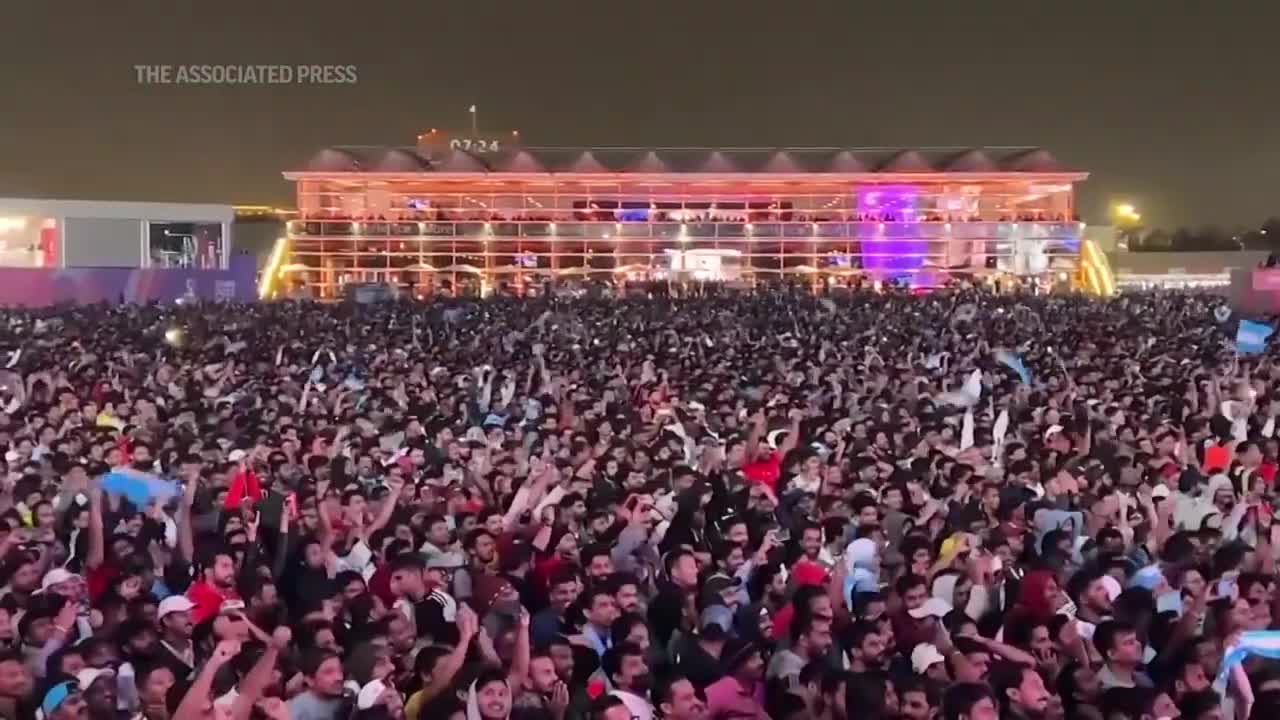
0;0;1280;227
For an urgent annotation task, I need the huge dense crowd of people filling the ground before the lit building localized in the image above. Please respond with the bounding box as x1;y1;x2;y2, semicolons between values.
0;290;1280;720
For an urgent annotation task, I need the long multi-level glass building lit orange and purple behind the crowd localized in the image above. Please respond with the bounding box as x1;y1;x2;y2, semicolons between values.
277;139;1088;297
